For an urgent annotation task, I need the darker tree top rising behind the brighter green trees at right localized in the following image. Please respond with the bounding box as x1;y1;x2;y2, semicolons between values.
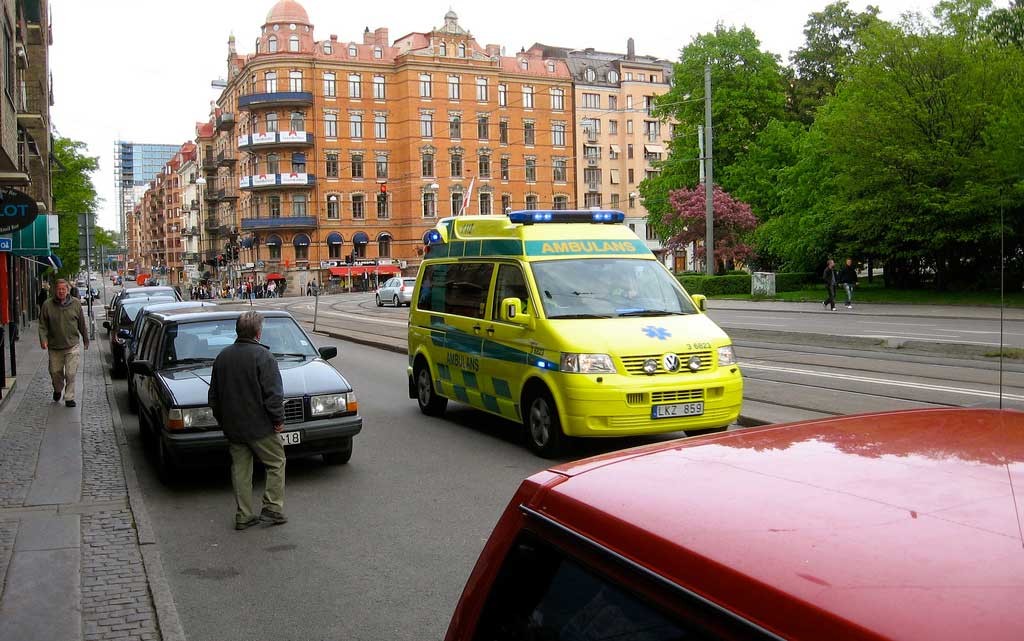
790;0;879;125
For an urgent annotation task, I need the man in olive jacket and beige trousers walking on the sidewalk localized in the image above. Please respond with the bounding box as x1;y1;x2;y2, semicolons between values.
39;279;89;408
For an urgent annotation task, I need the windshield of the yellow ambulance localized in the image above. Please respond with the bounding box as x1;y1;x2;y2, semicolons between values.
530;258;696;318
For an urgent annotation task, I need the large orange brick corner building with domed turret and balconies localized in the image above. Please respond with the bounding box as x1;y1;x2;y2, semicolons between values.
207;0;577;289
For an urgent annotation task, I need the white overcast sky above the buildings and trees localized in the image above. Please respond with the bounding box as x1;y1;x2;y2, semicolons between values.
51;0;946;228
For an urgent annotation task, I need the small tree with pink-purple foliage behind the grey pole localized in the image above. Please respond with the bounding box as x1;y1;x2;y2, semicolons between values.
662;184;758;267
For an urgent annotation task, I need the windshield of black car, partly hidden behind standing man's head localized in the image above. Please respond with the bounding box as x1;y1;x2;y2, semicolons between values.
161;317;318;368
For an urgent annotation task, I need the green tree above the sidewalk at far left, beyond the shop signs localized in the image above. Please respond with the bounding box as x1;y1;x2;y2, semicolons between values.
52;137;99;276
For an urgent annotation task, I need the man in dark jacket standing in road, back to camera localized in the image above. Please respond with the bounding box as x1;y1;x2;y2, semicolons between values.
208;311;288;529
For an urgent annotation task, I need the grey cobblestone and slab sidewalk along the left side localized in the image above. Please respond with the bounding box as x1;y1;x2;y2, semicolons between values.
0;332;161;641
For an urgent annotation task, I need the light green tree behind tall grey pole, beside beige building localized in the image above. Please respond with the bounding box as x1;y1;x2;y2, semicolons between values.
639;25;786;238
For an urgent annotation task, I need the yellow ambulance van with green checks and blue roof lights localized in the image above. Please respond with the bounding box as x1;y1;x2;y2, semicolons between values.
409;210;743;457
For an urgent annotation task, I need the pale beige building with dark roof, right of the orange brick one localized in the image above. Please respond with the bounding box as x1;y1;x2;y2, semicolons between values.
530;38;685;271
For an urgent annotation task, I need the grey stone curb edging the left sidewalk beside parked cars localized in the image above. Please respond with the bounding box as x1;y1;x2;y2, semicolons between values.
93;339;185;641
